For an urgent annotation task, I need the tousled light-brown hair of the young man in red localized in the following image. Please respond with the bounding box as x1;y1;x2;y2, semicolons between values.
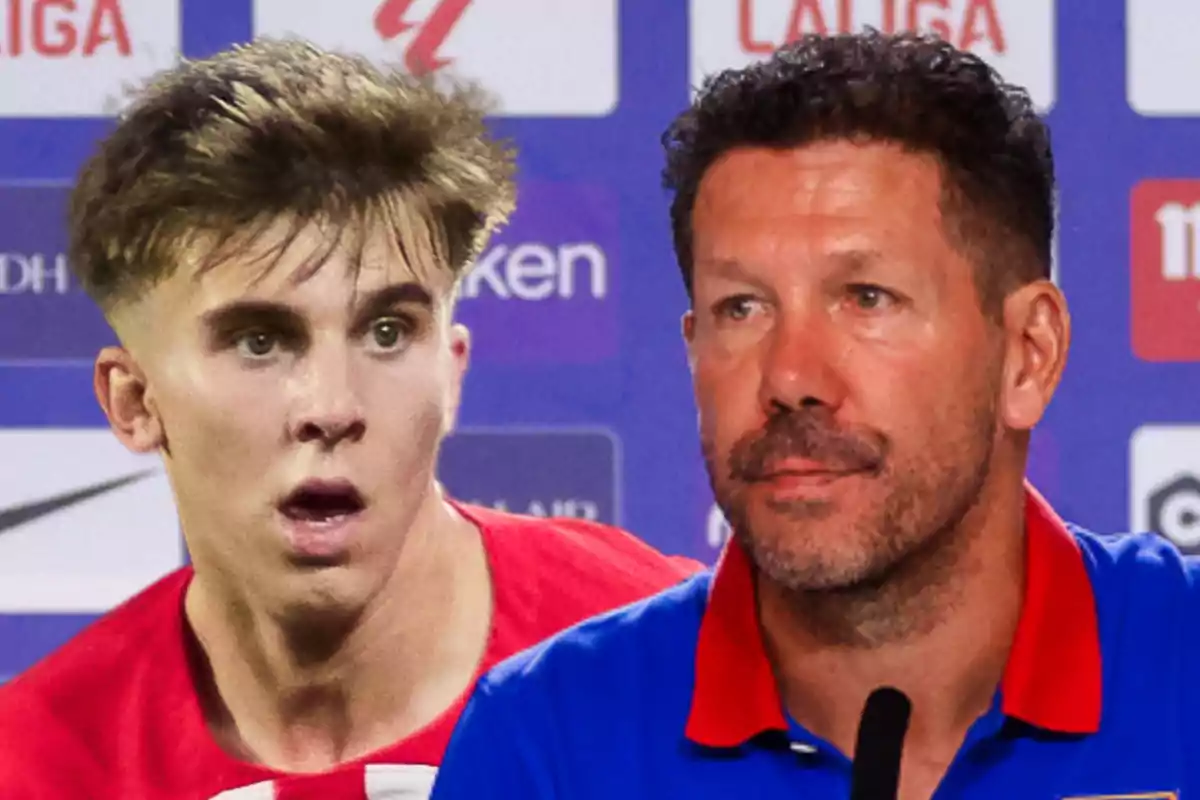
68;38;515;313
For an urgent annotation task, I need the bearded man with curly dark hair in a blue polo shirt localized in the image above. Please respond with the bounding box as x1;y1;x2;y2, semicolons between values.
433;32;1200;800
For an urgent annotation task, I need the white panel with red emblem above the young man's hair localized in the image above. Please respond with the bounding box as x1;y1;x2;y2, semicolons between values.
254;0;618;116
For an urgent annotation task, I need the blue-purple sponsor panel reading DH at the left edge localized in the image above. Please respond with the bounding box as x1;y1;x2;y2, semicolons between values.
0;185;115;365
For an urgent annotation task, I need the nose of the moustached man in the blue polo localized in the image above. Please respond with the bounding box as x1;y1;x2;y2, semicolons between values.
758;312;847;416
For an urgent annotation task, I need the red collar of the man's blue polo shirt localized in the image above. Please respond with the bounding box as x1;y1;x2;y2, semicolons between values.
686;486;1100;747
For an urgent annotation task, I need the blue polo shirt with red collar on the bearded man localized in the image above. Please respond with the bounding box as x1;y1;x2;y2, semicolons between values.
432;488;1200;800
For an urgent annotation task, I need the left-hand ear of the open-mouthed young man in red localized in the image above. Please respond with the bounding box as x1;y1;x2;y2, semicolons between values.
92;347;163;453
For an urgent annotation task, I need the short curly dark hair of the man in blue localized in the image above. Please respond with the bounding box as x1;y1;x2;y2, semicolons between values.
662;29;1055;307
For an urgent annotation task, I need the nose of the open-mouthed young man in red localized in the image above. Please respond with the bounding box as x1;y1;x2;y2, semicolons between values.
288;354;366;450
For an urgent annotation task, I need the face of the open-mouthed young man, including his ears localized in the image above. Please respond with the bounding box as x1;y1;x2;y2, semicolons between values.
97;217;468;614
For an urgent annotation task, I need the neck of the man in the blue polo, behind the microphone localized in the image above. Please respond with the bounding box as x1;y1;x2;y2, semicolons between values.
758;474;1025;768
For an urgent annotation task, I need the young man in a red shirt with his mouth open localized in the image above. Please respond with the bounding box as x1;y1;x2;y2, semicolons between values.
0;41;698;800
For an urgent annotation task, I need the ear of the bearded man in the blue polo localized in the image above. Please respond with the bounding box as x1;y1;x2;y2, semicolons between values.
1000;281;1070;431
